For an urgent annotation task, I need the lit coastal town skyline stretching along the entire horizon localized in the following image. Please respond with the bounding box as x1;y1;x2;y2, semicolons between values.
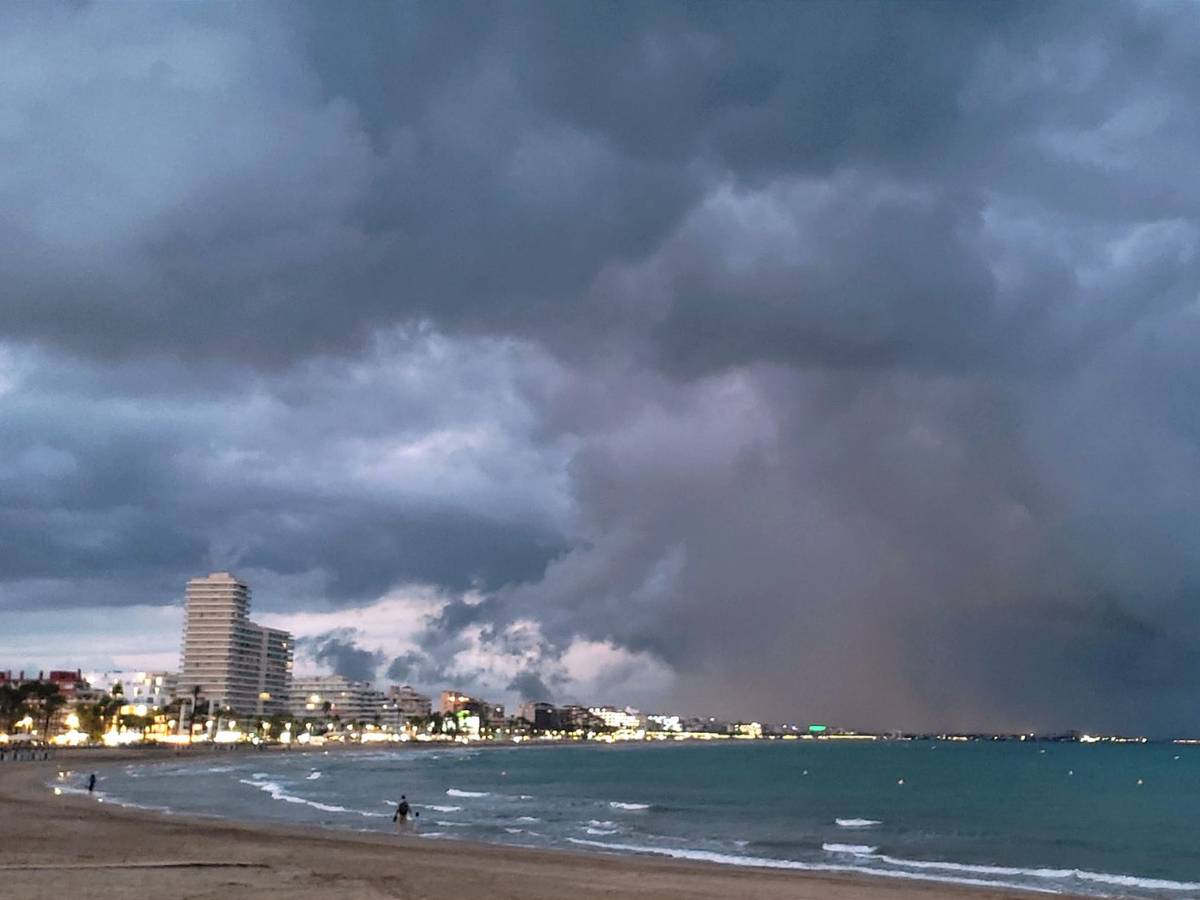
0;571;1200;744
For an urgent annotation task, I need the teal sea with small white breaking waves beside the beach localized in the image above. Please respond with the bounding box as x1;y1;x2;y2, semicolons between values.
72;740;1200;898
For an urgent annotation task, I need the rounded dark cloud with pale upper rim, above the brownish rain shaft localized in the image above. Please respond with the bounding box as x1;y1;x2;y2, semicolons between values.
649;184;1006;372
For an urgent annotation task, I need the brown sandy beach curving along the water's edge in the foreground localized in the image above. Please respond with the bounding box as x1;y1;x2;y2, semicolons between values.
0;752;1046;900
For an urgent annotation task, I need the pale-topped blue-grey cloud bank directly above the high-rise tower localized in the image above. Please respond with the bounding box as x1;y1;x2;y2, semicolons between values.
0;341;565;608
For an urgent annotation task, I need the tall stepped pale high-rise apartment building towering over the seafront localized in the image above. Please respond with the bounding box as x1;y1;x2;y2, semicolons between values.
178;572;292;715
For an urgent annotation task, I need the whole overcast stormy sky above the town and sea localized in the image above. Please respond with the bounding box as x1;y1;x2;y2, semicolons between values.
0;2;1200;733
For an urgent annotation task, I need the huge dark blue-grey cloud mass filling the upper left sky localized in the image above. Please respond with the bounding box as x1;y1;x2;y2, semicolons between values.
0;4;1051;365
